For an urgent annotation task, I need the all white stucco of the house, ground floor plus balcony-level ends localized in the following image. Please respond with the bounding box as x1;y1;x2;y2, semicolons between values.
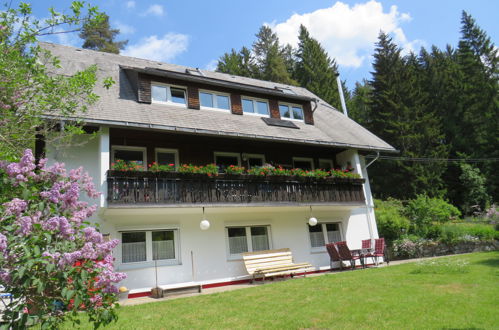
47;129;377;292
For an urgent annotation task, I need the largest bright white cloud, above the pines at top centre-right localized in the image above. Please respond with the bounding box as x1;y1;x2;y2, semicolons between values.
269;0;423;68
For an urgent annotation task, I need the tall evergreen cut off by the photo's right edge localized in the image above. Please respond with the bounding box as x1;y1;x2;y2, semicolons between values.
453;11;499;200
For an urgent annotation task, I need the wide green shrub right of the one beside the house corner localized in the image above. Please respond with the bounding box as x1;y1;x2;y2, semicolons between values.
406;195;461;237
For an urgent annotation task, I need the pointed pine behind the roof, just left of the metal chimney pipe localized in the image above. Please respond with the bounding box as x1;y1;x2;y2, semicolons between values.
294;25;340;108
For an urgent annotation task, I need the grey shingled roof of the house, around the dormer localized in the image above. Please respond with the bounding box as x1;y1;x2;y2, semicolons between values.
41;43;395;151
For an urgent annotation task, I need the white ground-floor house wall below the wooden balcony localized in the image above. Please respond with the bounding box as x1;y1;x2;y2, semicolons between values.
102;206;369;292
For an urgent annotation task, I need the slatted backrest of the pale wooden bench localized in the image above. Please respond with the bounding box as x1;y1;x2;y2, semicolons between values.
243;248;293;274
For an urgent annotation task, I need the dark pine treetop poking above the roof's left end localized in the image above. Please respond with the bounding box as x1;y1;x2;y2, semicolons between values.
79;14;128;54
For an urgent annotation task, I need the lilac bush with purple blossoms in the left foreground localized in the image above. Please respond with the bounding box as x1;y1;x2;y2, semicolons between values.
0;150;125;328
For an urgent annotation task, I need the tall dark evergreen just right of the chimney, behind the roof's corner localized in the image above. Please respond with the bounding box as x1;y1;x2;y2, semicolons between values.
366;33;447;199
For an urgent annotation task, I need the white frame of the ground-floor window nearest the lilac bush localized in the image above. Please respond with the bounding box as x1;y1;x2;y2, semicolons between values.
116;227;182;270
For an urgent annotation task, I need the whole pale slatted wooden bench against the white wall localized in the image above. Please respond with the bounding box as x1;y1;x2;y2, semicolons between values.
243;248;313;281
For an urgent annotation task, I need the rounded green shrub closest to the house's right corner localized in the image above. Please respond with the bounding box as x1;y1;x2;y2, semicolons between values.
374;199;410;241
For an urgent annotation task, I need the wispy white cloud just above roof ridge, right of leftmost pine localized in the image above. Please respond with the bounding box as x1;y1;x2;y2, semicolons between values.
123;33;189;62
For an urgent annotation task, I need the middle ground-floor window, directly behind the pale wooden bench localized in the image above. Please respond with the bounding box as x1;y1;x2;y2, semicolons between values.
226;226;270;256
